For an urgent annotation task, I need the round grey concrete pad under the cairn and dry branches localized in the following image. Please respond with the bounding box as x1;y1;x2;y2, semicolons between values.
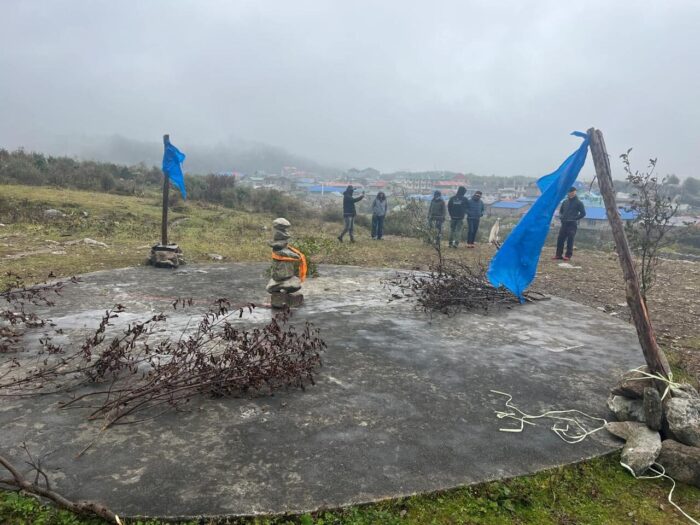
0;264;642;517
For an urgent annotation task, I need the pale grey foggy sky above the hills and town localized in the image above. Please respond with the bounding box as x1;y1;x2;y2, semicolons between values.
0;0;700;177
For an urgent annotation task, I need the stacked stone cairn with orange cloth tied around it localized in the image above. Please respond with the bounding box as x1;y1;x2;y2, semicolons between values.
267;218;306;308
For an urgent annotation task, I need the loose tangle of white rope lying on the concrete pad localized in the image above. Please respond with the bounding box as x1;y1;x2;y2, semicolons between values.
491;390;607;444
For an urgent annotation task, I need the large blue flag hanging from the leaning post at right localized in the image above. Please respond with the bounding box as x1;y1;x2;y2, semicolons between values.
486;131;588;303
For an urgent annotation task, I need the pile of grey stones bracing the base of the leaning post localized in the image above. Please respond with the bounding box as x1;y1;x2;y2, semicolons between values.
605;367;700;487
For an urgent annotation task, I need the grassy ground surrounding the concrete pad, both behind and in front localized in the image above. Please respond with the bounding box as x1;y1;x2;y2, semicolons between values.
0;186;700;525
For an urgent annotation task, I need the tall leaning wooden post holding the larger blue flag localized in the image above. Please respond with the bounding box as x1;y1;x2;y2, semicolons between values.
588;128;671;379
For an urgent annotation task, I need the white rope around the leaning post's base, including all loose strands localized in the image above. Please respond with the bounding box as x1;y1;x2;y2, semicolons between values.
491;388;700;525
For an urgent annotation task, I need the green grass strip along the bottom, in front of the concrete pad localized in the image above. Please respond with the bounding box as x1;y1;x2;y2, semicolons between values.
0;454;700;525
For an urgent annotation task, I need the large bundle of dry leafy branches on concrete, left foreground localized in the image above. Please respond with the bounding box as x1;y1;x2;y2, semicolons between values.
0;299;326;428
